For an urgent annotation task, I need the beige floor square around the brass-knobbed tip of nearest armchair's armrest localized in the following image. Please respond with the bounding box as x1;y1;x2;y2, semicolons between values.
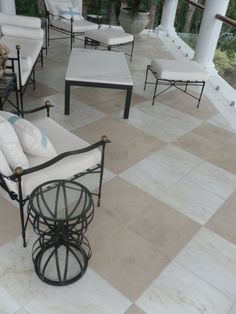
74;117;162;174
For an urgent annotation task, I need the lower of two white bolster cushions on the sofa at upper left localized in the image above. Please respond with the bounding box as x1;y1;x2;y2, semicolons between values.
1;24;44;40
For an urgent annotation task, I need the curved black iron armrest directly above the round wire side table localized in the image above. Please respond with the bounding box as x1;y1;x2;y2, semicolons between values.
10;135;111;181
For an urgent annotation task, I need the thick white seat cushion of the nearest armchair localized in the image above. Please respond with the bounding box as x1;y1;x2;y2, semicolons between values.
22;118;101;195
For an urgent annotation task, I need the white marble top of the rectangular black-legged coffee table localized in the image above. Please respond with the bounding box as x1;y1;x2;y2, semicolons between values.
66;48;133;86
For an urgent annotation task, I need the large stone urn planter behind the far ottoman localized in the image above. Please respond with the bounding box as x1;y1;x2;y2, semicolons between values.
119;8;149;38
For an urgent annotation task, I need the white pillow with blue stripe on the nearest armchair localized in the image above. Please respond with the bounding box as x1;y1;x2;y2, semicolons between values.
0;111;57;158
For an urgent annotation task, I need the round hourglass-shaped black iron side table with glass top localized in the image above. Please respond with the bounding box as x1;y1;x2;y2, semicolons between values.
28;180;94;286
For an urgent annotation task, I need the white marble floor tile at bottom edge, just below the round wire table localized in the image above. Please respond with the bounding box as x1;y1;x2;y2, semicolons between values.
24;268;132;314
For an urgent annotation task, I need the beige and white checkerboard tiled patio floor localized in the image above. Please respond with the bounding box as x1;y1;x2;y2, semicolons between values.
0;30;236;314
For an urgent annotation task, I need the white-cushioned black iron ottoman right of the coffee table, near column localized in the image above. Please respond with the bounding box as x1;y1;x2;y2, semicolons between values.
144;59;208;107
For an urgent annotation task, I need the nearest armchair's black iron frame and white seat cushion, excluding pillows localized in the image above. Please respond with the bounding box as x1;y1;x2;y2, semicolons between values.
0;102;110;246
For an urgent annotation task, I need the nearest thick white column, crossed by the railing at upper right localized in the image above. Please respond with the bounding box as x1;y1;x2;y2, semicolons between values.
193;0;229;72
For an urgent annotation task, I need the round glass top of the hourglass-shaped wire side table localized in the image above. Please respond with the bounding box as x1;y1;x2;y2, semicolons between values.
28;180;93;221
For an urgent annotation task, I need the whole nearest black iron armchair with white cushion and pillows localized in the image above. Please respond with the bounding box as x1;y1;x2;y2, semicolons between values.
0;102;109;246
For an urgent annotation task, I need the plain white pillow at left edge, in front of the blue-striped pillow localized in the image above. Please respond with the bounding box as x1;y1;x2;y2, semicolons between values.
0;116;29;170
